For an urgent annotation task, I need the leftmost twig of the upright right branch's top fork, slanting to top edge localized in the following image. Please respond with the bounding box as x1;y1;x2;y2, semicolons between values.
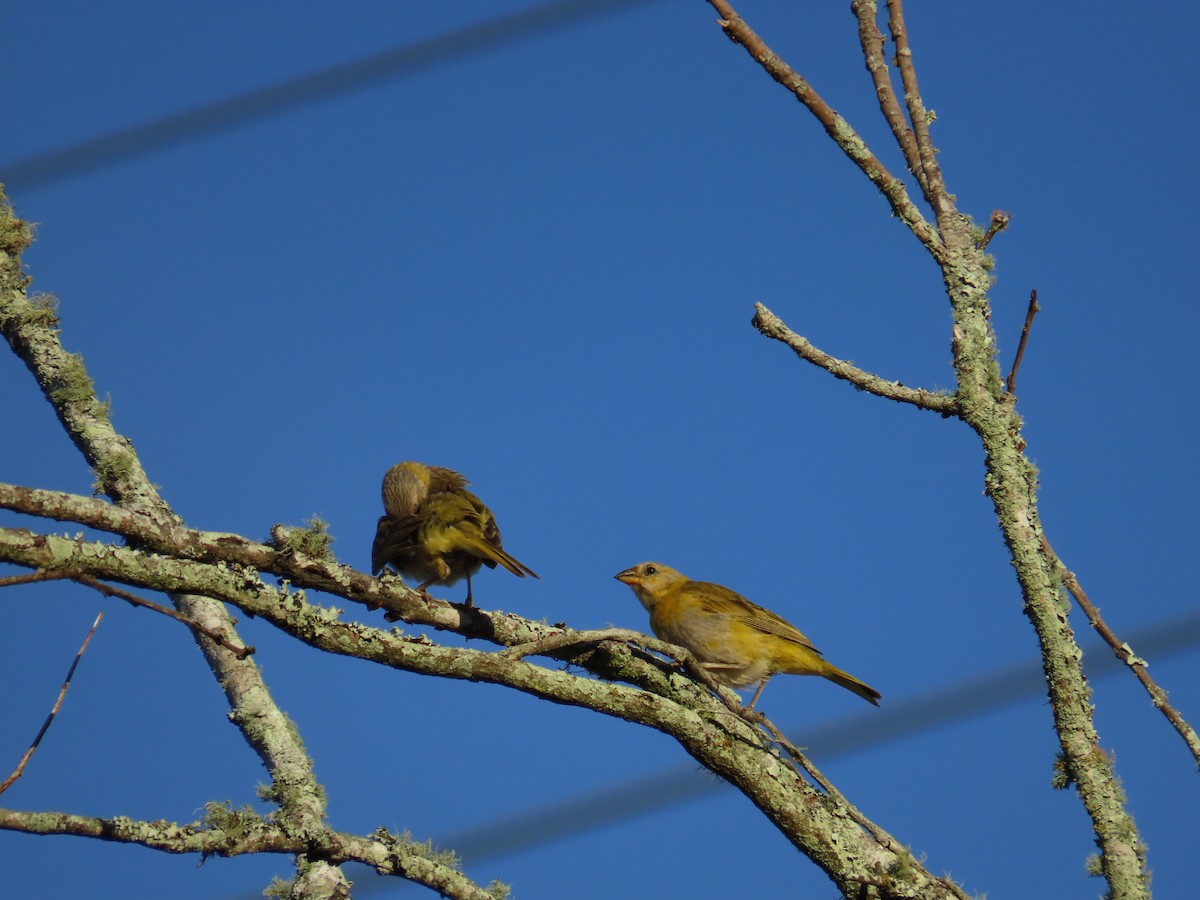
708;0;947;263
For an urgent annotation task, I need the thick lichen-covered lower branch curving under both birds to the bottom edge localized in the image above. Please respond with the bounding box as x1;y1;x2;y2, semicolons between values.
0;529;961;896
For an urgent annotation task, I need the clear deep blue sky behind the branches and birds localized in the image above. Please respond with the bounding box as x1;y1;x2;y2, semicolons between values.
0;0;1200;900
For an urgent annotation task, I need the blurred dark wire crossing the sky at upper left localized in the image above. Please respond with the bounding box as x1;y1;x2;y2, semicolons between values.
0;0;654;191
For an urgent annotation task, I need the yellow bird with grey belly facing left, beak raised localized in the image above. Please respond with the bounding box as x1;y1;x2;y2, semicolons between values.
613;563;880;709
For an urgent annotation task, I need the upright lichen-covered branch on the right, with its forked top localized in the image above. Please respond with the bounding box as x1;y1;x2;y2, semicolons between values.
709;0;1148;899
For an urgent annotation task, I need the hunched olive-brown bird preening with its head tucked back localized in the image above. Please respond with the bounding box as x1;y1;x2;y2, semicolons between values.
371;462;538;606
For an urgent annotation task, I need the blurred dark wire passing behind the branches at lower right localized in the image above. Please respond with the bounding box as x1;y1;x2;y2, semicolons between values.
326;613;1200;894
